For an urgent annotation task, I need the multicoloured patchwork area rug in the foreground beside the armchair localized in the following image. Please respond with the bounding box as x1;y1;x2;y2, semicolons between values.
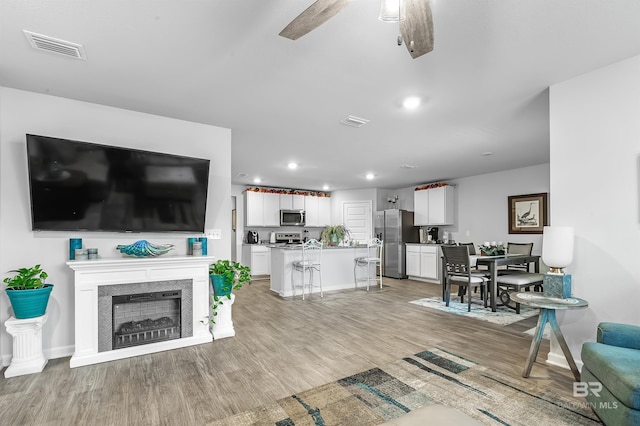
213;348;600;426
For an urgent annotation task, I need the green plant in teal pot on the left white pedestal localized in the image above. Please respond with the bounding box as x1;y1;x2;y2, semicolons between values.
4;265;53;319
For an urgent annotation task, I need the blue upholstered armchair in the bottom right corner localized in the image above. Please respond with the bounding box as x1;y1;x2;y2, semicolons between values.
580;322;640;426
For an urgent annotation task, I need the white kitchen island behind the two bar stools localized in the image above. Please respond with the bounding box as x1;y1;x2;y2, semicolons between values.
271;245;375;297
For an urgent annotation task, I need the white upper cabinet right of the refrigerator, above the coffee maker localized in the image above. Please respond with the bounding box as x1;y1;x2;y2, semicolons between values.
413;185;455;226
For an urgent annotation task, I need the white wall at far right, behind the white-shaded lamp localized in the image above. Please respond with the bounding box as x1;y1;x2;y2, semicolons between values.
550;56;640;362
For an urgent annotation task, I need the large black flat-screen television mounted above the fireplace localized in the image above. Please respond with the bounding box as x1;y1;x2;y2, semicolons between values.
27;134;209;233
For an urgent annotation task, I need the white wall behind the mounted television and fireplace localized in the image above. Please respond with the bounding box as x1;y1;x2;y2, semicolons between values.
0;87;231;365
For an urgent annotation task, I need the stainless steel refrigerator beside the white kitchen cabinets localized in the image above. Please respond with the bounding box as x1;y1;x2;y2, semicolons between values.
374;210;420;279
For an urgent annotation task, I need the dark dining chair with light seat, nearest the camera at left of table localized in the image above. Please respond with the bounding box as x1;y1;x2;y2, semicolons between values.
441;245;489;312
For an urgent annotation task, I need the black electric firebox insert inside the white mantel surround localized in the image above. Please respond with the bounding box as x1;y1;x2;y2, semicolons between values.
111;290;182;349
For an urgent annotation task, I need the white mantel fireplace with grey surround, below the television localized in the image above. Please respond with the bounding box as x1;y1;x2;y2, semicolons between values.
67;256;214;368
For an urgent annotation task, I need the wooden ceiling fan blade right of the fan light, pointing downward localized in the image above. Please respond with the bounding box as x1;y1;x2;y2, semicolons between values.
400;0;433;59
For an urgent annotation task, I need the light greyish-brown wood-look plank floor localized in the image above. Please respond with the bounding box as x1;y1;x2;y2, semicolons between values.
0;278;573;425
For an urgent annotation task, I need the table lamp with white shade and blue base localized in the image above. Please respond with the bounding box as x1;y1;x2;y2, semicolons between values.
542;226;573;299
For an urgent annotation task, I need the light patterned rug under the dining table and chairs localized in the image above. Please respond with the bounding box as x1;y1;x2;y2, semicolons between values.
409;297;538;325
